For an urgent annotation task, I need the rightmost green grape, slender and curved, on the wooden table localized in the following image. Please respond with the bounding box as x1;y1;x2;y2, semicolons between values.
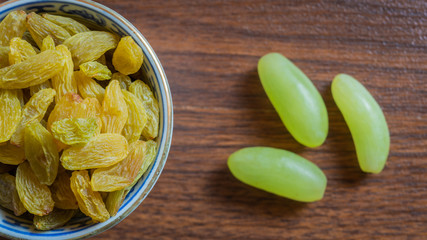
331;74;390;173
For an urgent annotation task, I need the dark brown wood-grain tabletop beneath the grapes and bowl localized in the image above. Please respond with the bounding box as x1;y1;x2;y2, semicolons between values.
3;0;427;240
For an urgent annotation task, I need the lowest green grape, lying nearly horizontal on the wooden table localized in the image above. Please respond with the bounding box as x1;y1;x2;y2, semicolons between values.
228;147;327;202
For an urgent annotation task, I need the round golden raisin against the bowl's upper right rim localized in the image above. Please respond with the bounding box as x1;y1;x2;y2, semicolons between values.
113;36;144;75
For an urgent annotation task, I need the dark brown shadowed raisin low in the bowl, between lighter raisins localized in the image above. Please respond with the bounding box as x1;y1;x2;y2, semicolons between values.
50;170;79;209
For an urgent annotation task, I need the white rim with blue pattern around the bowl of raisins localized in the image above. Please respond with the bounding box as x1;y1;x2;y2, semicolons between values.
0;0;173;239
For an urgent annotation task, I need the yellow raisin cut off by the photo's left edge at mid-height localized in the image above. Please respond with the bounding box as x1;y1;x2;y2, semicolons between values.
0;89;22;143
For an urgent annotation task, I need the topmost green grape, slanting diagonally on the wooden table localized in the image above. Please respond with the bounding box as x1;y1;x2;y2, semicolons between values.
258;53;328;147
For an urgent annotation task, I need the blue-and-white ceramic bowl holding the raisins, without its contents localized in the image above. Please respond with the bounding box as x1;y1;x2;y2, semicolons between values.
0;0;173;240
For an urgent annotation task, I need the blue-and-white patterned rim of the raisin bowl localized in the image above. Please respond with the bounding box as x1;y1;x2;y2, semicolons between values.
0;0;173;239
